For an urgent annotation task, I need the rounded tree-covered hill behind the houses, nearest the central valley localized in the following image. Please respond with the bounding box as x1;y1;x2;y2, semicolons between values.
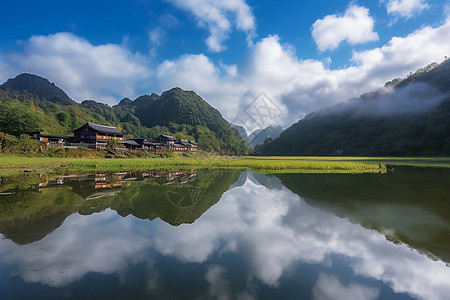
114;88;249;154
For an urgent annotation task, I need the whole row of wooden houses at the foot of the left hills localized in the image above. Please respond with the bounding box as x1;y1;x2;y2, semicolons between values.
30;122;198;154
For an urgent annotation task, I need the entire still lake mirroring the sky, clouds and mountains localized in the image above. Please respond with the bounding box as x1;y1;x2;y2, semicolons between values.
0;168;450;299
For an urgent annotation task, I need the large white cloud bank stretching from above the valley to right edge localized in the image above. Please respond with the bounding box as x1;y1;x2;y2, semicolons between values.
157;18;450;131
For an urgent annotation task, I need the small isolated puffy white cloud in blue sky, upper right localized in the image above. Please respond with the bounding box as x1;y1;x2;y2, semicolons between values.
311;5;378;51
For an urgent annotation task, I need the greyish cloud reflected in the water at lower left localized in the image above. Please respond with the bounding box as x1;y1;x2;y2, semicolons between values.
0;210;150;287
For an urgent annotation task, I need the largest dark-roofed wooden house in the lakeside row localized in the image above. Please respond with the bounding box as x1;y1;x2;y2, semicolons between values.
73;122;123;150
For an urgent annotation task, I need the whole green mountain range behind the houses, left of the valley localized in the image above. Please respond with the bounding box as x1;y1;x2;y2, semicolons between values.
0;74;249;154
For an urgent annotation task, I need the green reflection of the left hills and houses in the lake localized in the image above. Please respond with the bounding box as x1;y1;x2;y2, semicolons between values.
0;170;240;244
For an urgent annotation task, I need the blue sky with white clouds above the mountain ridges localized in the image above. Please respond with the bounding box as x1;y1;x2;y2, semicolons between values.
0;0;450;131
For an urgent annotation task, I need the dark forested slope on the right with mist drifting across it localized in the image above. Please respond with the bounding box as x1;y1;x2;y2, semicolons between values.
255;60;450;156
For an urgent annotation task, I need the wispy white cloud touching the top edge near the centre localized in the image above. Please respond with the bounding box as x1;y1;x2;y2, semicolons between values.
167;0;255;52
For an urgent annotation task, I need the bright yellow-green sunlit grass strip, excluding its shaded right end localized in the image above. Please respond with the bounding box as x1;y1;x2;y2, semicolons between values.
0;156;386;175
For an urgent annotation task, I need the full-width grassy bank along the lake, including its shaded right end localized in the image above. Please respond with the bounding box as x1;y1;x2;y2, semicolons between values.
0;156;450;176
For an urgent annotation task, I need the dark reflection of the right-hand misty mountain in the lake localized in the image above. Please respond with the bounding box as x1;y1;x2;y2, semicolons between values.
277;168;450;262
